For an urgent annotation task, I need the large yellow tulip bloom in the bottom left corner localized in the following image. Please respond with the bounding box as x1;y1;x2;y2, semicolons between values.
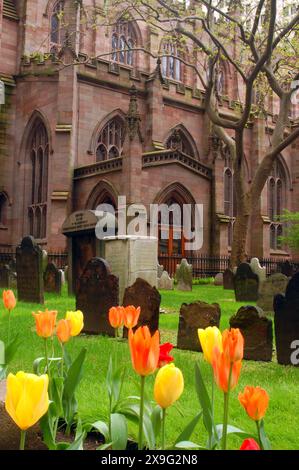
5;371;50;431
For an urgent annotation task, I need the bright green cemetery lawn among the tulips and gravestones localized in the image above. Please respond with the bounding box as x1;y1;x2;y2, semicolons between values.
0;285;299;449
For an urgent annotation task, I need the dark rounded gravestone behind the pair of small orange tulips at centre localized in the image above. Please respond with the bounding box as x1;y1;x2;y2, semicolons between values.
123;278;161;337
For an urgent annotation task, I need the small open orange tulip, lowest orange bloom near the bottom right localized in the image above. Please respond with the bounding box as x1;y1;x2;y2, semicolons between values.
238;385;269;421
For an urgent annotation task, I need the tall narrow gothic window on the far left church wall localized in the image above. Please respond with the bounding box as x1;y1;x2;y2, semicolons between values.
28;119;49;239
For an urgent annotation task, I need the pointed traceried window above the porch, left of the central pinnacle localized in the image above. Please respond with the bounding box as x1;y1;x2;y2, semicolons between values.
96;117;125;162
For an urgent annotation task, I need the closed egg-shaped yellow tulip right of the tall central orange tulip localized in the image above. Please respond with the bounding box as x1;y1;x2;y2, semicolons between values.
154;363;184;408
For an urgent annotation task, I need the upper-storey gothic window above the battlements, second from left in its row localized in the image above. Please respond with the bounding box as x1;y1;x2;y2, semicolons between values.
111;20;137;66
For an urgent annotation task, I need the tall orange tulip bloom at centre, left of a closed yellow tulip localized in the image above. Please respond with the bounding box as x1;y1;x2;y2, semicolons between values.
129;326;160;377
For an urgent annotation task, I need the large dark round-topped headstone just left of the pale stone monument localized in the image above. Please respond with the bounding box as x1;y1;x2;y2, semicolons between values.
76;258;118;336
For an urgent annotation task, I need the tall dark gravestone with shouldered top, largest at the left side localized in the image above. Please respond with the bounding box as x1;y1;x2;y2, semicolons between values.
16;236;44;304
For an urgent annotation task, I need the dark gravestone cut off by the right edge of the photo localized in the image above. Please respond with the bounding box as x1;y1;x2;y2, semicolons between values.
274;273;299;366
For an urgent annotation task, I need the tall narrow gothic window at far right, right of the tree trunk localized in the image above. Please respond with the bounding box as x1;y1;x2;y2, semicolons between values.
268;161;286;250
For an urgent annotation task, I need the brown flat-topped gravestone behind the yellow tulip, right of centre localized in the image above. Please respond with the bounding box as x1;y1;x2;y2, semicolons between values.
177;300;221;351
